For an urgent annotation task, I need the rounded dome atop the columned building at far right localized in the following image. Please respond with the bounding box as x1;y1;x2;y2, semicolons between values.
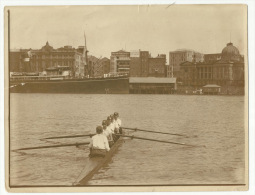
221;42;241;61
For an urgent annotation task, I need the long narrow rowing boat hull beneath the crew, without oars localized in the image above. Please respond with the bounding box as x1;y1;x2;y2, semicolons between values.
74;136;123;186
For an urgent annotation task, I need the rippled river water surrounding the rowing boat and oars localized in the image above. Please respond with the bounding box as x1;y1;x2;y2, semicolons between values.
10;94;245;186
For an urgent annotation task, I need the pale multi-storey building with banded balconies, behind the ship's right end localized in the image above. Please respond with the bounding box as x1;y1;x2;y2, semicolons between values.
110;50;130;75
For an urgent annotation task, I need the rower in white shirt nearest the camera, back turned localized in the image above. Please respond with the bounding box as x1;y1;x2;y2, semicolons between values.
89;126;110;157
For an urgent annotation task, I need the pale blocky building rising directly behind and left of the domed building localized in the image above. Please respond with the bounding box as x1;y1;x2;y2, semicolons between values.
169;49;204;78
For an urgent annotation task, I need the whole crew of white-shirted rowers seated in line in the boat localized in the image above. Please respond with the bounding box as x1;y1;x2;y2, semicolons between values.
89;112;122;157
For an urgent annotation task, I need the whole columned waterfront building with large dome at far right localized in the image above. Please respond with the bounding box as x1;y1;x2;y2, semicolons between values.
179;43;244;94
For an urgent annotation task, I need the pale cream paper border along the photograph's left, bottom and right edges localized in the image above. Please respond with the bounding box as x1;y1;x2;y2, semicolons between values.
1;2;254;192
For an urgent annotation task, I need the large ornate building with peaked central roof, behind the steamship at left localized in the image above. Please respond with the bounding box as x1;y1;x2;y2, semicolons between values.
10;41;84;77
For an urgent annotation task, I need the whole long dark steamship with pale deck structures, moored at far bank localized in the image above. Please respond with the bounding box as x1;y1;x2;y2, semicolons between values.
9;67;129;94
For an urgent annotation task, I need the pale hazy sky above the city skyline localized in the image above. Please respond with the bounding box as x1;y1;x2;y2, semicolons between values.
10;5;247;62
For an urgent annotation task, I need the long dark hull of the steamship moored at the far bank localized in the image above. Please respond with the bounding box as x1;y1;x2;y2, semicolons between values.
10;77;129;94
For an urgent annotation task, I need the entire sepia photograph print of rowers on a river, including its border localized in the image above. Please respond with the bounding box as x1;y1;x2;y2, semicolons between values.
5;4;248;191
